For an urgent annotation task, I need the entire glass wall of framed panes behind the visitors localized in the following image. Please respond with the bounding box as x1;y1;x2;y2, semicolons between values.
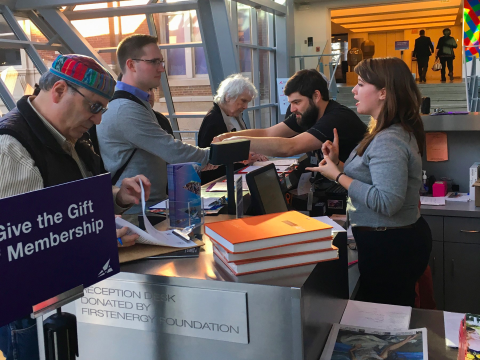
0;0;282;139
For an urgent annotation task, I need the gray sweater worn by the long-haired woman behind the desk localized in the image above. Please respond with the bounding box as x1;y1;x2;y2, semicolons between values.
340;125;422;227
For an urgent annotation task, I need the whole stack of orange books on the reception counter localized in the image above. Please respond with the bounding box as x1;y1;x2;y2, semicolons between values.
205;211;338;275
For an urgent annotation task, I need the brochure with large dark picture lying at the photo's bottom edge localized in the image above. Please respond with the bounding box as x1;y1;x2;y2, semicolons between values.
320;324;428;360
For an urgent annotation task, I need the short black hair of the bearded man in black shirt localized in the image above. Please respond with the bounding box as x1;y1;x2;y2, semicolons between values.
284;69;330;101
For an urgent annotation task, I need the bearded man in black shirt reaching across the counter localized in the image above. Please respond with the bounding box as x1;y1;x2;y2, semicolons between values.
213;70;367;162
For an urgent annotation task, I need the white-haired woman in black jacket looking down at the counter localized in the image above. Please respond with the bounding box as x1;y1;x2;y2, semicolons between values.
198;74;257;184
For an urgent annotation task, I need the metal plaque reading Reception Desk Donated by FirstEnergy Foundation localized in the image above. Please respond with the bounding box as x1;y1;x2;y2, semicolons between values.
75;279;249;344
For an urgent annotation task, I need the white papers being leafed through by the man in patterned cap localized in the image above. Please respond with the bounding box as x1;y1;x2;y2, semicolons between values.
115;180;197;248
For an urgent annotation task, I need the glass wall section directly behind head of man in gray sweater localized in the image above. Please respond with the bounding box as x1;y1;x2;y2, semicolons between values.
72;0;212;130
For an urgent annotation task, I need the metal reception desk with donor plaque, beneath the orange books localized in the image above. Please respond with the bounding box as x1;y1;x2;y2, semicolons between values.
66;215;349;360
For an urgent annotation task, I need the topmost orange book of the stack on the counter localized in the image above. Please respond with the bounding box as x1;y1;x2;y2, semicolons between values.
205;211;332;252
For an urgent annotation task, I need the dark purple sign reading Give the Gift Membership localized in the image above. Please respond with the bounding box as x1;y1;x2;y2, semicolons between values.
0;174;119;326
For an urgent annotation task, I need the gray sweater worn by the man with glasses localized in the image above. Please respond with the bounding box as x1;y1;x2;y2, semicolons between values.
97;99;210;201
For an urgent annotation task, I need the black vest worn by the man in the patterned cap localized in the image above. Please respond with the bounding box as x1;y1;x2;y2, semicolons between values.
0;96;105;187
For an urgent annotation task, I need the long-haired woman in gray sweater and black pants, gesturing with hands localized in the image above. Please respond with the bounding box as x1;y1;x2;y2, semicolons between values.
309;58;432;306
